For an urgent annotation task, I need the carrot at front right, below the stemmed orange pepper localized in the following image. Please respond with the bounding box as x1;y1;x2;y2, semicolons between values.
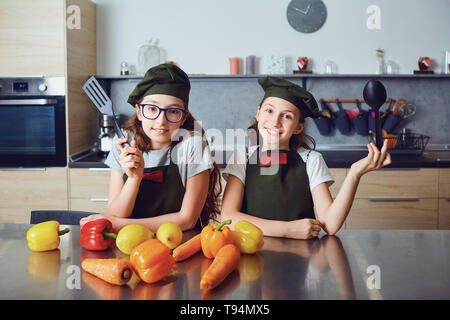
200;244;241;289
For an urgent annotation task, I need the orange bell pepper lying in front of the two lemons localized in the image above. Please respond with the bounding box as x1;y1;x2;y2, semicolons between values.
130;239;175;283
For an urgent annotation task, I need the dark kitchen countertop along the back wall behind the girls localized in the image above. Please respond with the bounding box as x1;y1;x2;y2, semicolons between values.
69;150;450;169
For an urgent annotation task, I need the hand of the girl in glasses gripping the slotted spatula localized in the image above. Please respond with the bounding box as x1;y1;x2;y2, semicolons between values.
116;138;144;181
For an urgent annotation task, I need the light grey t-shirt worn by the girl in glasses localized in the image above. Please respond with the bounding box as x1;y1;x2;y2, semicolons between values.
105;133;214;187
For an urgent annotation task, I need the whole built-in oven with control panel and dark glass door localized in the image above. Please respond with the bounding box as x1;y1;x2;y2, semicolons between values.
0;77;67;167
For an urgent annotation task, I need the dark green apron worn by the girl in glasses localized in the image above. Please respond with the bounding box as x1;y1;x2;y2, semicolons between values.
123;146;185;218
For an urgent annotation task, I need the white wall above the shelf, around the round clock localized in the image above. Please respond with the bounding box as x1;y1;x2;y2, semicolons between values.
94;0;450;75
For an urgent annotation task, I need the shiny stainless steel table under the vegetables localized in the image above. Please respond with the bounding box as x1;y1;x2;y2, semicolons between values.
0;224;450;300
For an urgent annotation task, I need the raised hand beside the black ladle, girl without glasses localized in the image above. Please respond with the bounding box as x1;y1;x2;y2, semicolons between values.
350;139;392;177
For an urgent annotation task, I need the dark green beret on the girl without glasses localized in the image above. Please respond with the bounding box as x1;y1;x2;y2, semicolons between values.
258;76;319;118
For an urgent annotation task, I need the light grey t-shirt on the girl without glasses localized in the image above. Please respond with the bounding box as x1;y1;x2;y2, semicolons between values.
223;146;334;191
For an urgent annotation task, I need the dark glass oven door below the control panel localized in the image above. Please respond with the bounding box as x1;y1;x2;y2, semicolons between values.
0;96;67;167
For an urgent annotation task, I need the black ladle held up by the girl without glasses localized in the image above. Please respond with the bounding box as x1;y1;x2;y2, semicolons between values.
363;80;387;150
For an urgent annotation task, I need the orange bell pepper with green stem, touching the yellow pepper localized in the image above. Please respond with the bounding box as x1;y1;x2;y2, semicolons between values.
201;220;234;259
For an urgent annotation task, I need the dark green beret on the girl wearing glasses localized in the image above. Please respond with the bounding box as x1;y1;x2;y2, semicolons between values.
128;63;191;108
